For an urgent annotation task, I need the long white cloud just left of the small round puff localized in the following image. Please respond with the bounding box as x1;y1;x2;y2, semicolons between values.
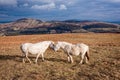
31;3;56;10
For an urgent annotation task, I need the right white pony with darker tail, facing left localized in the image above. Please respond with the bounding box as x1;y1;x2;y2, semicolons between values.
53;41;89;64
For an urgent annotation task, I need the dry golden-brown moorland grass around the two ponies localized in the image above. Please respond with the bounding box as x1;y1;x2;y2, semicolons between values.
0;33;120;80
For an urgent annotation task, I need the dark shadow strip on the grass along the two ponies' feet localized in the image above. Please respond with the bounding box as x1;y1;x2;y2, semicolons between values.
0;55;67;63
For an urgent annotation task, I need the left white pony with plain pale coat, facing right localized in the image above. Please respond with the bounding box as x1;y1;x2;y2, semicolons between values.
21;41;54;63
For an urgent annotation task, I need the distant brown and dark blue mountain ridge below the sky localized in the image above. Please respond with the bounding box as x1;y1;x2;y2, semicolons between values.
0;18;120;36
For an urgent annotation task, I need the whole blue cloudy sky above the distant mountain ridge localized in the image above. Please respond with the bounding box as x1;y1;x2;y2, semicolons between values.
0;0;120;21
